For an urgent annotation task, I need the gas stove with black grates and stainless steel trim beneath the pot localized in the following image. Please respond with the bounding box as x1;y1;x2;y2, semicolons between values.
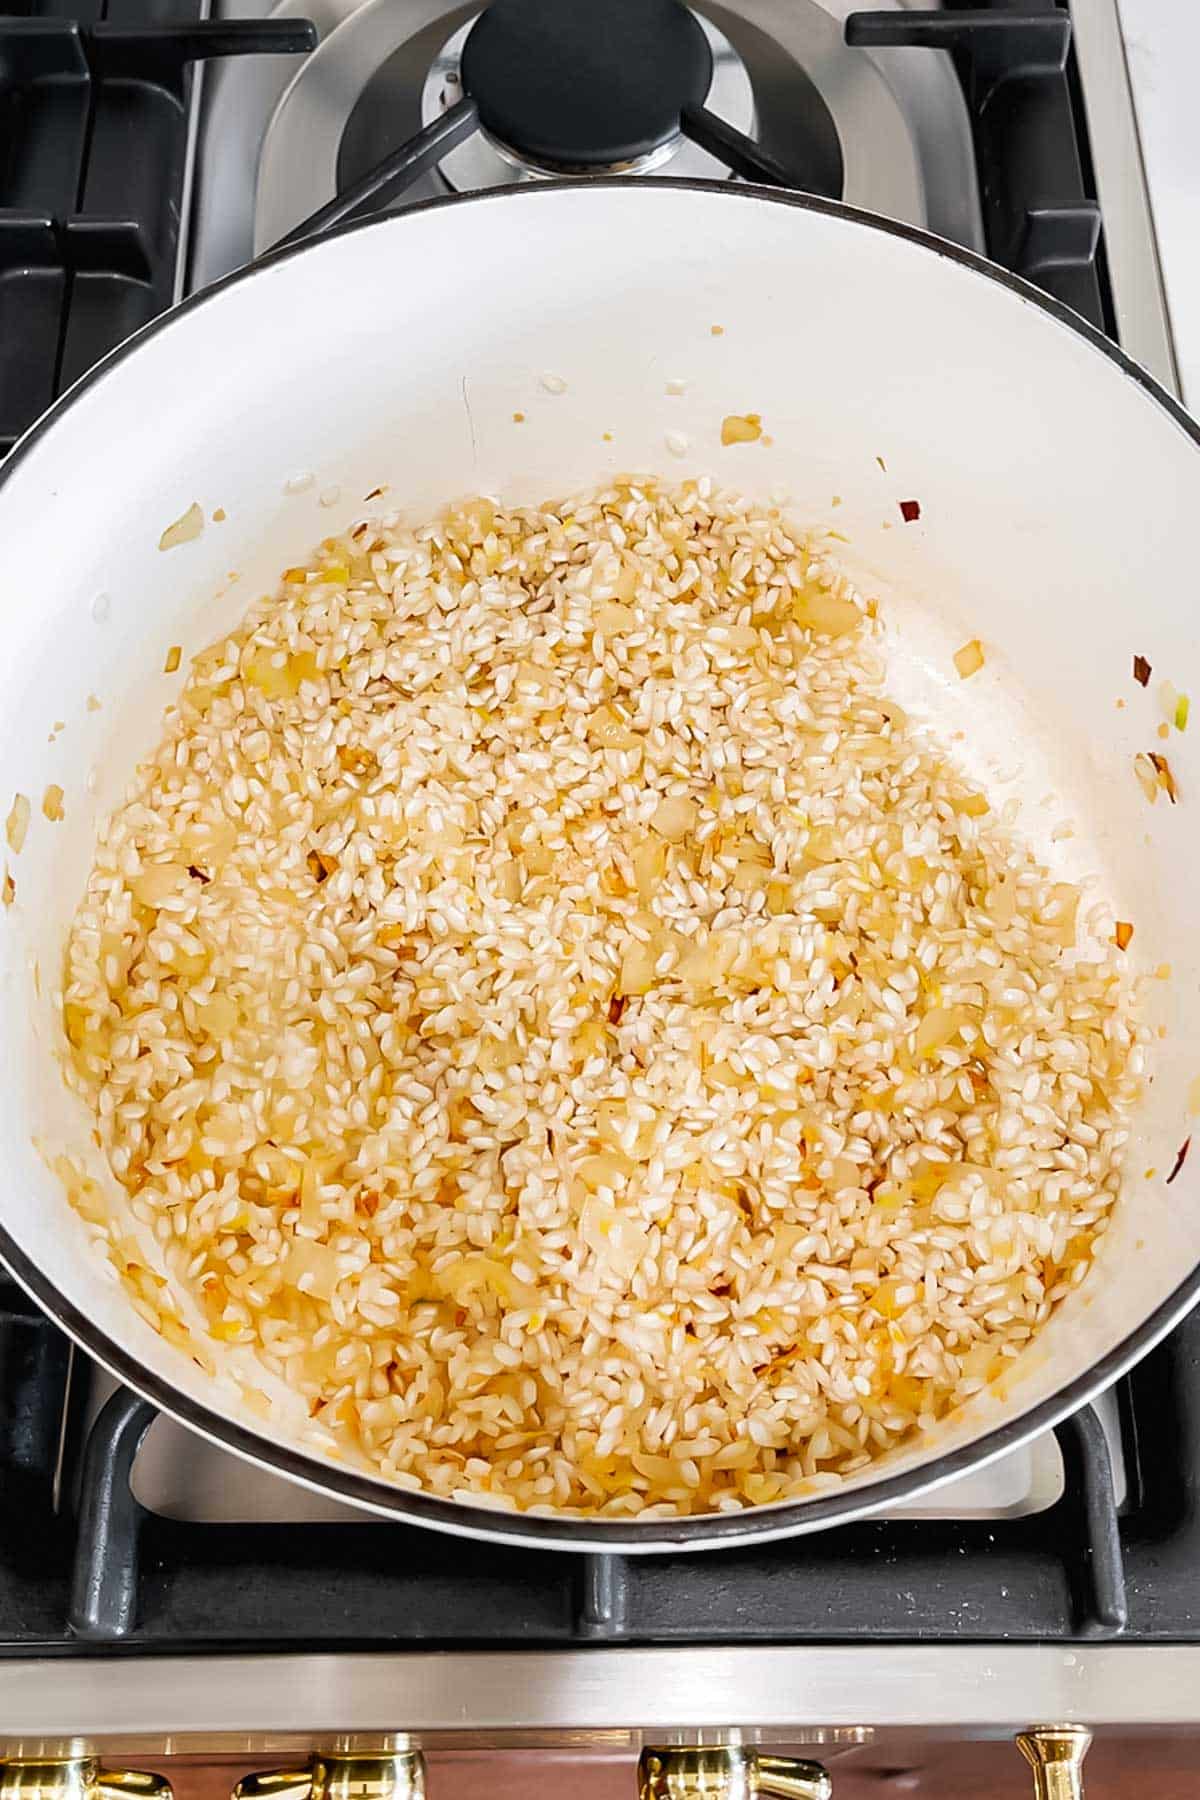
0;0;1200;1800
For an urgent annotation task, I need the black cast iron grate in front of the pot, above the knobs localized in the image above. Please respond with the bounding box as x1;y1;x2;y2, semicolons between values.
0;1294;1200;1654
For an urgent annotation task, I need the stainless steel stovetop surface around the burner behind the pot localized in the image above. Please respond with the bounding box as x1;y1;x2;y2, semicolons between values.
178;0;1178;391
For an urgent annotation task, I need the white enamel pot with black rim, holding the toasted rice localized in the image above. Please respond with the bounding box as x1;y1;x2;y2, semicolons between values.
0;182;1200;1550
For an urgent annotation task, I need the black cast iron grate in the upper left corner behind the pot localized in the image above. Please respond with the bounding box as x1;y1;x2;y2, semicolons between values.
0;0;317;455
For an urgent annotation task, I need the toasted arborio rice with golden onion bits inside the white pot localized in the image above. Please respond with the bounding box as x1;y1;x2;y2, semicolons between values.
63;481;1142;1516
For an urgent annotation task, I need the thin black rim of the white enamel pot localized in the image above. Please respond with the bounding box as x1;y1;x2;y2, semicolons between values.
0;176;1200;1555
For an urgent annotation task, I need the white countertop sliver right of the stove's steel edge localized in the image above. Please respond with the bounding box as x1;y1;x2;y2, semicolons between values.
1119;0;1200;414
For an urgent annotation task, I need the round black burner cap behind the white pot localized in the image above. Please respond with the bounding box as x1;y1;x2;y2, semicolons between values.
462;0;712;171
